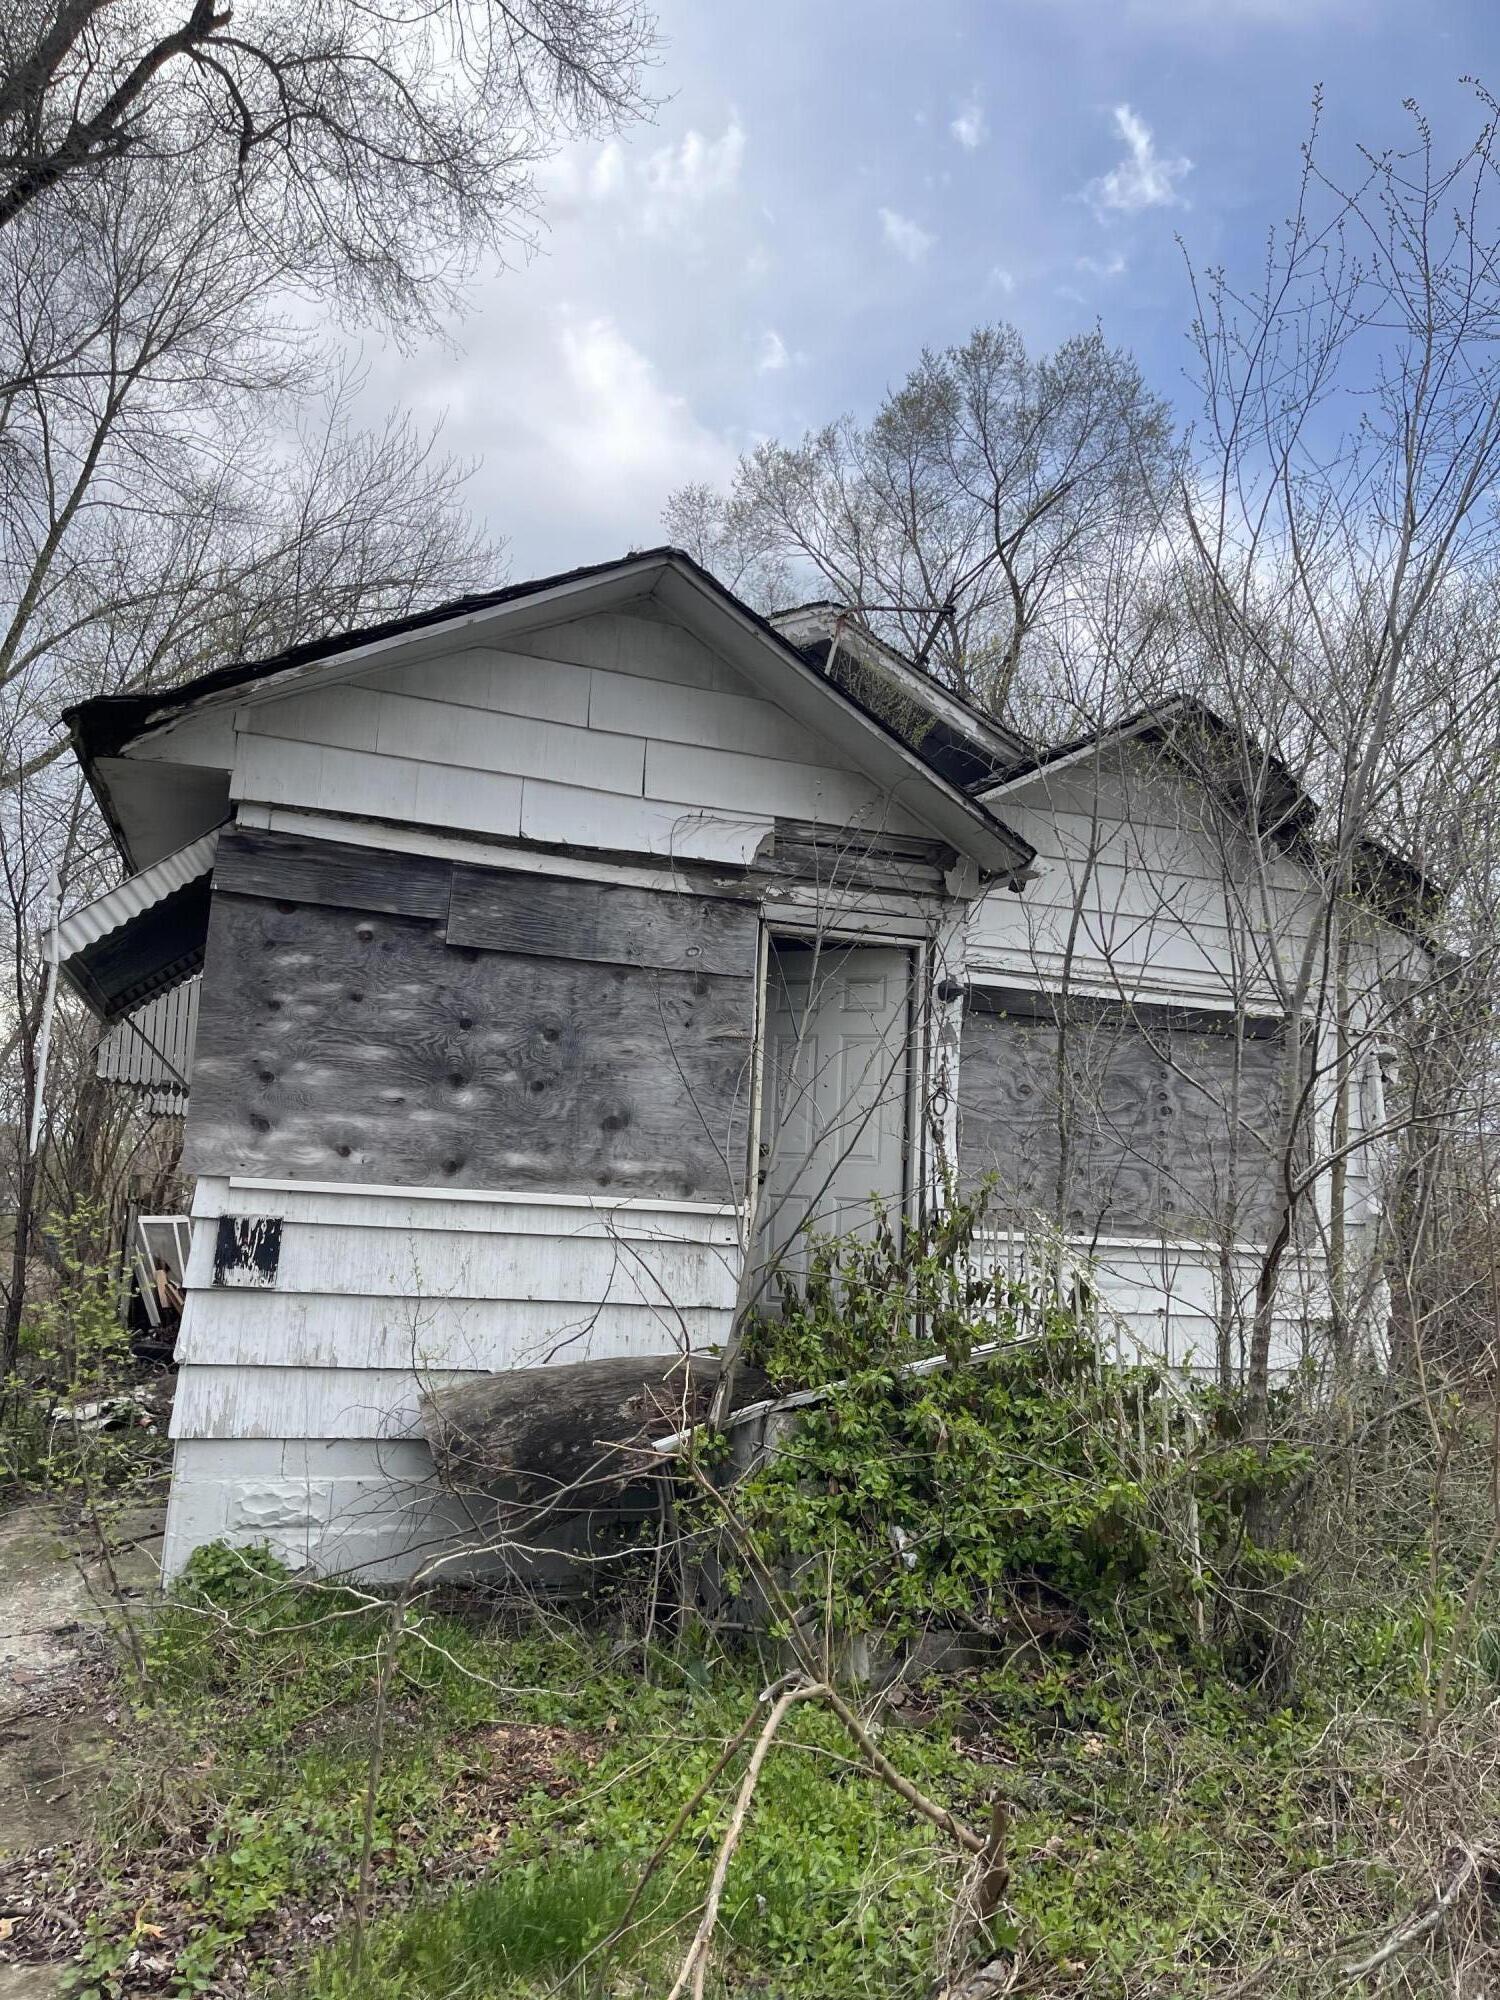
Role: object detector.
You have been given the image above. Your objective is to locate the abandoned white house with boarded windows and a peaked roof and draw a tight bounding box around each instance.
[58,550,1424,1572]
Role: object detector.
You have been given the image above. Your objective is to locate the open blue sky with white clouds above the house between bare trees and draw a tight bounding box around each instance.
[364,0,1500,576]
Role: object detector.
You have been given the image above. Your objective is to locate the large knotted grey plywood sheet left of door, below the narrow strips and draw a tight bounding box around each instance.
[184,894,754,1200]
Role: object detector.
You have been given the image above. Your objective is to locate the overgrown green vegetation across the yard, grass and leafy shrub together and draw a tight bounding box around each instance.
[2,1204,1500,2000]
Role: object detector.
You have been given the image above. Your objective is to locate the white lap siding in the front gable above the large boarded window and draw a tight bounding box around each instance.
[232,612,924,862]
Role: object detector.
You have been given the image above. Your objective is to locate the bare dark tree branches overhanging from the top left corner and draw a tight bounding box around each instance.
[0,0,654,324]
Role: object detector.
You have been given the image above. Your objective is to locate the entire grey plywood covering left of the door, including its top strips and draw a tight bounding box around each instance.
[186,834,756,1202]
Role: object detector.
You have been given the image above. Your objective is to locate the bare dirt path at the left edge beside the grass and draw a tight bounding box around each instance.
[0,1502,164,2000]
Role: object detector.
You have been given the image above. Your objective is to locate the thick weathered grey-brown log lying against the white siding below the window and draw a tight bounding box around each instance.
[420,1354,768,1512]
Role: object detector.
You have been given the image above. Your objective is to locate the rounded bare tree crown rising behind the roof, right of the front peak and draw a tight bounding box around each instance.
[666,326,1174,716]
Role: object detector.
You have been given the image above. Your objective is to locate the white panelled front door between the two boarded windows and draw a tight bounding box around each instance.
[760,940,912,1270]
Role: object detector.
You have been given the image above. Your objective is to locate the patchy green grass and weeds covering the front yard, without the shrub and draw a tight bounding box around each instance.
[55,1556,1500,2000]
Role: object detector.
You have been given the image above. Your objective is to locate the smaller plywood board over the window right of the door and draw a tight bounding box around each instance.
[958,988,1284,1238]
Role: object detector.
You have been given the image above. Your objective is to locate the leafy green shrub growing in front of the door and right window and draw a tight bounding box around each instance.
[722,1198,1304,1636]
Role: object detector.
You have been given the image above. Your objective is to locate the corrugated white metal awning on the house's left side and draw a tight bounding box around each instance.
[56,830,218,1020]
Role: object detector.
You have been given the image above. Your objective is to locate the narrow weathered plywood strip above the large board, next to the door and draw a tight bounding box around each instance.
[448,862,758,980]
